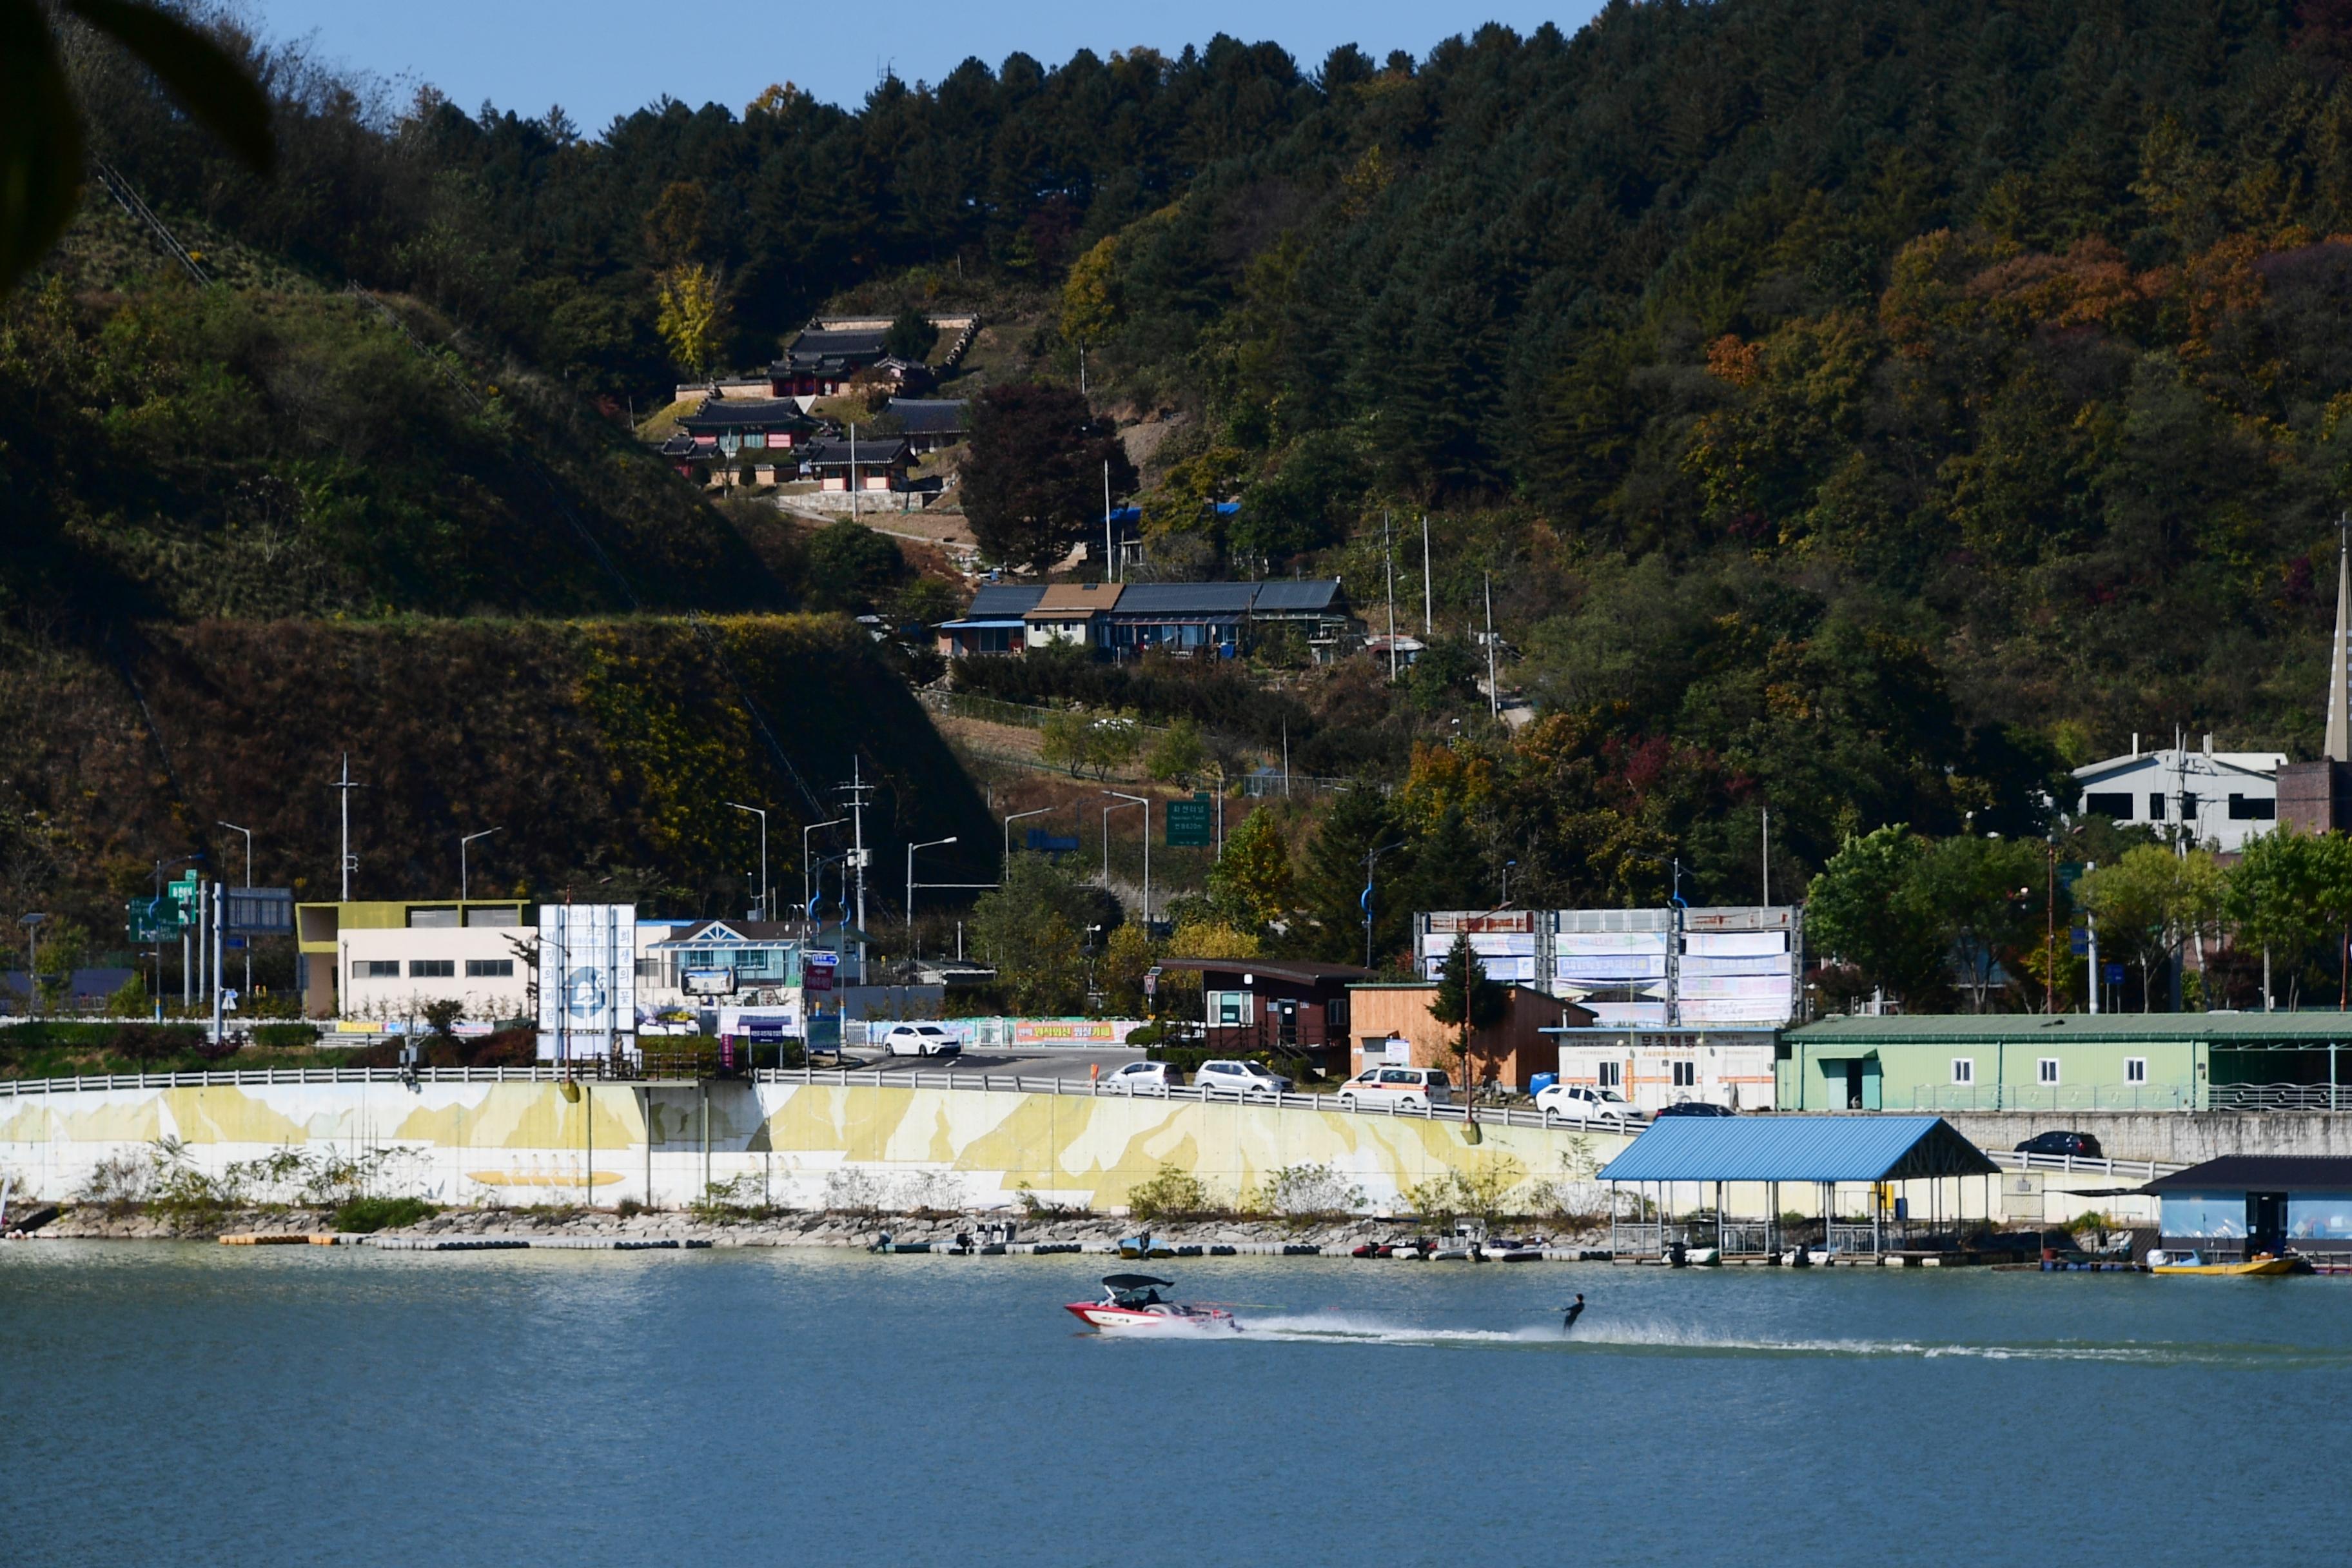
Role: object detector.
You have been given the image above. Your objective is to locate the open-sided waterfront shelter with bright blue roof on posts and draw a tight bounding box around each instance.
[1600,1117,1999,1255]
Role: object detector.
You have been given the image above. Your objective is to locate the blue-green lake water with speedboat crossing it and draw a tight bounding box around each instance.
[0,1241,2352,1568]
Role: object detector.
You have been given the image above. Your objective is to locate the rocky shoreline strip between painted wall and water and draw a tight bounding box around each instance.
[10,1204,1609,1253]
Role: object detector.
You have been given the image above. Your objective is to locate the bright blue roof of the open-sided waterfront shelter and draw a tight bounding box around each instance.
[1602,1117,1999,1182]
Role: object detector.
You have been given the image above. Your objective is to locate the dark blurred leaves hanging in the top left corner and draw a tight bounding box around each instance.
[0,0,277,294]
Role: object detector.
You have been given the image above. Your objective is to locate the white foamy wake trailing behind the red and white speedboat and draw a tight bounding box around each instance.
[1237,1312,2352,1368]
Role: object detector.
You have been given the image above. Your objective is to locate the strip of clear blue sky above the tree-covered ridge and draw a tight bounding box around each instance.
[244,0,1600,134]
